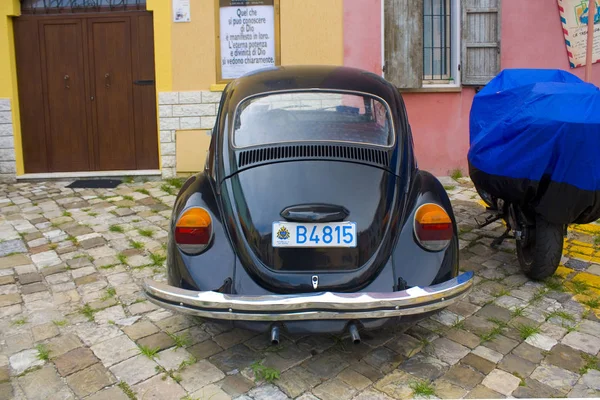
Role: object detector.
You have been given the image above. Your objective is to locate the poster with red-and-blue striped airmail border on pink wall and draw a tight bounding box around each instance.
[558,0,600,68]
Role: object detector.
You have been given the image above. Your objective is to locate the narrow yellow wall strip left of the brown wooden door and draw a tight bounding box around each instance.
[0,0,24,175]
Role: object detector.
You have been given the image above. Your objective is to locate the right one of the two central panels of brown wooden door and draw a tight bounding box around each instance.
[88,17,136,171]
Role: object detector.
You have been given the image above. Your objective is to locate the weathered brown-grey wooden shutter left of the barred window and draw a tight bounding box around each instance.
[384,0,423,89]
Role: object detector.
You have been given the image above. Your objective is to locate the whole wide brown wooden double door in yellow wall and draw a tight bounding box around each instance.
[14,12,158,173]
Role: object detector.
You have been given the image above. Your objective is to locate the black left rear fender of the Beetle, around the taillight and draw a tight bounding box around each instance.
[167,173,236,293]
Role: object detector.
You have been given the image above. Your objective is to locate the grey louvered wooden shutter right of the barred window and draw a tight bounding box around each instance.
[461,0,500,85]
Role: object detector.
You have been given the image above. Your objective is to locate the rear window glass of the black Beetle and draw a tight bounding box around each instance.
[233,91,393,147]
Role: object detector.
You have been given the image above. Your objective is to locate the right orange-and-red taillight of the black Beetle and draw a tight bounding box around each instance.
[414,203,454,251]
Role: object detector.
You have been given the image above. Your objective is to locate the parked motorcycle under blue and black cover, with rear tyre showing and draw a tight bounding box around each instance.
[468,69,600,279]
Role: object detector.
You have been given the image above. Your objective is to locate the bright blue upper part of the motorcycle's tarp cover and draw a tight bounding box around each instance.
[468,69,600,223]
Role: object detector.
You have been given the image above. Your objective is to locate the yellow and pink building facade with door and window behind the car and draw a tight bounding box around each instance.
[0,0,600,180]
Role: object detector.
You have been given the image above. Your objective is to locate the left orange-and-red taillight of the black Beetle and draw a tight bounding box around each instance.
[175,207,212,254]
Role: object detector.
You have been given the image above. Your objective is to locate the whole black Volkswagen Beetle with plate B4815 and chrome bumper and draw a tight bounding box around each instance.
[144,66,473,342]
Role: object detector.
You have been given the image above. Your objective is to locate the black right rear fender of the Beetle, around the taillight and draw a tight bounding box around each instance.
[392,171,458,290]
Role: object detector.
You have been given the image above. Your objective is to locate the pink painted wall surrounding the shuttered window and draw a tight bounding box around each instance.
[344,0,600,175]
